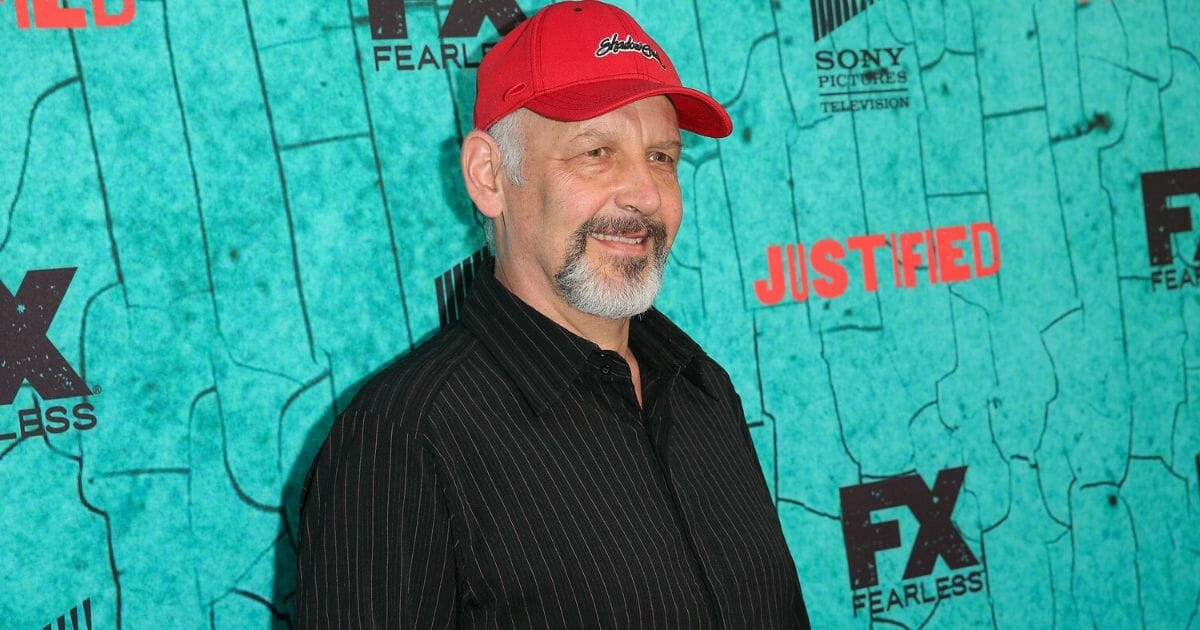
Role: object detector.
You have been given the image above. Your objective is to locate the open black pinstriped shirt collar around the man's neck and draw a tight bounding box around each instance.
[462,271,716,413]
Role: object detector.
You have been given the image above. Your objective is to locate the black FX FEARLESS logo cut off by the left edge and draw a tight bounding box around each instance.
[0,266,100,443]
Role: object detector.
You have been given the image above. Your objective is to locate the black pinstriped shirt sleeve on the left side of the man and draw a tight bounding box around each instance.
[295,412,457,629]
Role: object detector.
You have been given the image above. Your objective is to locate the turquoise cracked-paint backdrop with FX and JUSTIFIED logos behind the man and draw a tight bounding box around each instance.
[0,0,1200,629]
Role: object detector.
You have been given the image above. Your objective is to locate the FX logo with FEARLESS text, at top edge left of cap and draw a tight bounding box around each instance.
[367,0,526,72]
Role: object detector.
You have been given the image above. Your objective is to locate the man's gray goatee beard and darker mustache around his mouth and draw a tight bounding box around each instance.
[554,217,667,319]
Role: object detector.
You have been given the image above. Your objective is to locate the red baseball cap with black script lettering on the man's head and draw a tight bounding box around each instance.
[475,0,733,138]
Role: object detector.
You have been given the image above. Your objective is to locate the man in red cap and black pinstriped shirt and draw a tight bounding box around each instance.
[296,0,808,629]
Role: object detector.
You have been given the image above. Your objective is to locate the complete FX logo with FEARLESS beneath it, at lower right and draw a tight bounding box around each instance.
[840,466,986,618]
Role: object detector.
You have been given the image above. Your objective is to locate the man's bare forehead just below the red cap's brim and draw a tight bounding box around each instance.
[529,96,679,144]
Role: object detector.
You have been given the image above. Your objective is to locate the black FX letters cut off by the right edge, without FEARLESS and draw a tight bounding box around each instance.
[1141,168,1200,266]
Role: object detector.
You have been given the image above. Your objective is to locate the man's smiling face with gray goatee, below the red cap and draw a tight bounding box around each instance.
[498,96,683,318]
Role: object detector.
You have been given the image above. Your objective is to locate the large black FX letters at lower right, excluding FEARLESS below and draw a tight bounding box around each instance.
[840,466,979,590]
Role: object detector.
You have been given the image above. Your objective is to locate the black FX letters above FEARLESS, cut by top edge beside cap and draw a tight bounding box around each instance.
[367,0,524,40]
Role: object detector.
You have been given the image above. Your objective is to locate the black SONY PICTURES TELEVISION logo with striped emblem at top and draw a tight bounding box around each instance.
[810,0,908,114]
